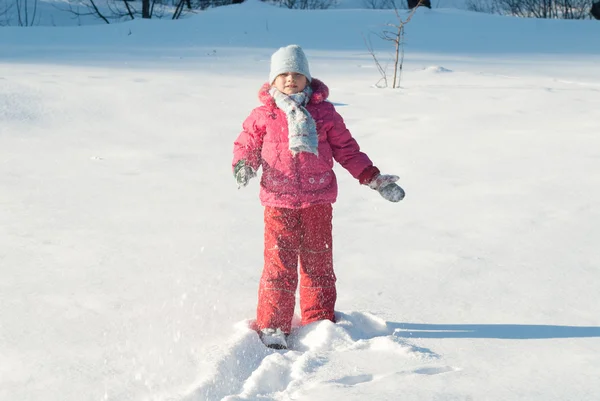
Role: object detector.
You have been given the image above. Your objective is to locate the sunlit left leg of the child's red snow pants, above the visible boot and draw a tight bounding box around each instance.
[256,207,301,333]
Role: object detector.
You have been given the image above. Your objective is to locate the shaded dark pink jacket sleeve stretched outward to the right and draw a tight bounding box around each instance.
[328,105,374,181]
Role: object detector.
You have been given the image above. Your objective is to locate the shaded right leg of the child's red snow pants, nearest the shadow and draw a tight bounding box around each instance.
[300,204,336,324]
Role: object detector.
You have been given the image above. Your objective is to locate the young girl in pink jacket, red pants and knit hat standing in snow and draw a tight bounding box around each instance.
[233,45,404,349]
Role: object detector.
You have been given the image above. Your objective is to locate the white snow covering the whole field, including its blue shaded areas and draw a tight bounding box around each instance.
[0,1,600,401]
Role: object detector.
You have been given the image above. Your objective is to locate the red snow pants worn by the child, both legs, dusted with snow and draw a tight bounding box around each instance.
[256,203,336,333]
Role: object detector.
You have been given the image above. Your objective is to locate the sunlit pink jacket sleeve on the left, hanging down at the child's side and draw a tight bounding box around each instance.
[232,107,266,171]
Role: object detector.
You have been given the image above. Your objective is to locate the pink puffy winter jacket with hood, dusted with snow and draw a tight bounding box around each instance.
[232,78,379,209]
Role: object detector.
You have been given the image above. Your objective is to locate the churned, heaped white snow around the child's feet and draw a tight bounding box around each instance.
[183,312,457,401]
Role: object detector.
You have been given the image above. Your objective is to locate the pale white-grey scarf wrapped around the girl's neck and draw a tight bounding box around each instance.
[269,86,319,156]
